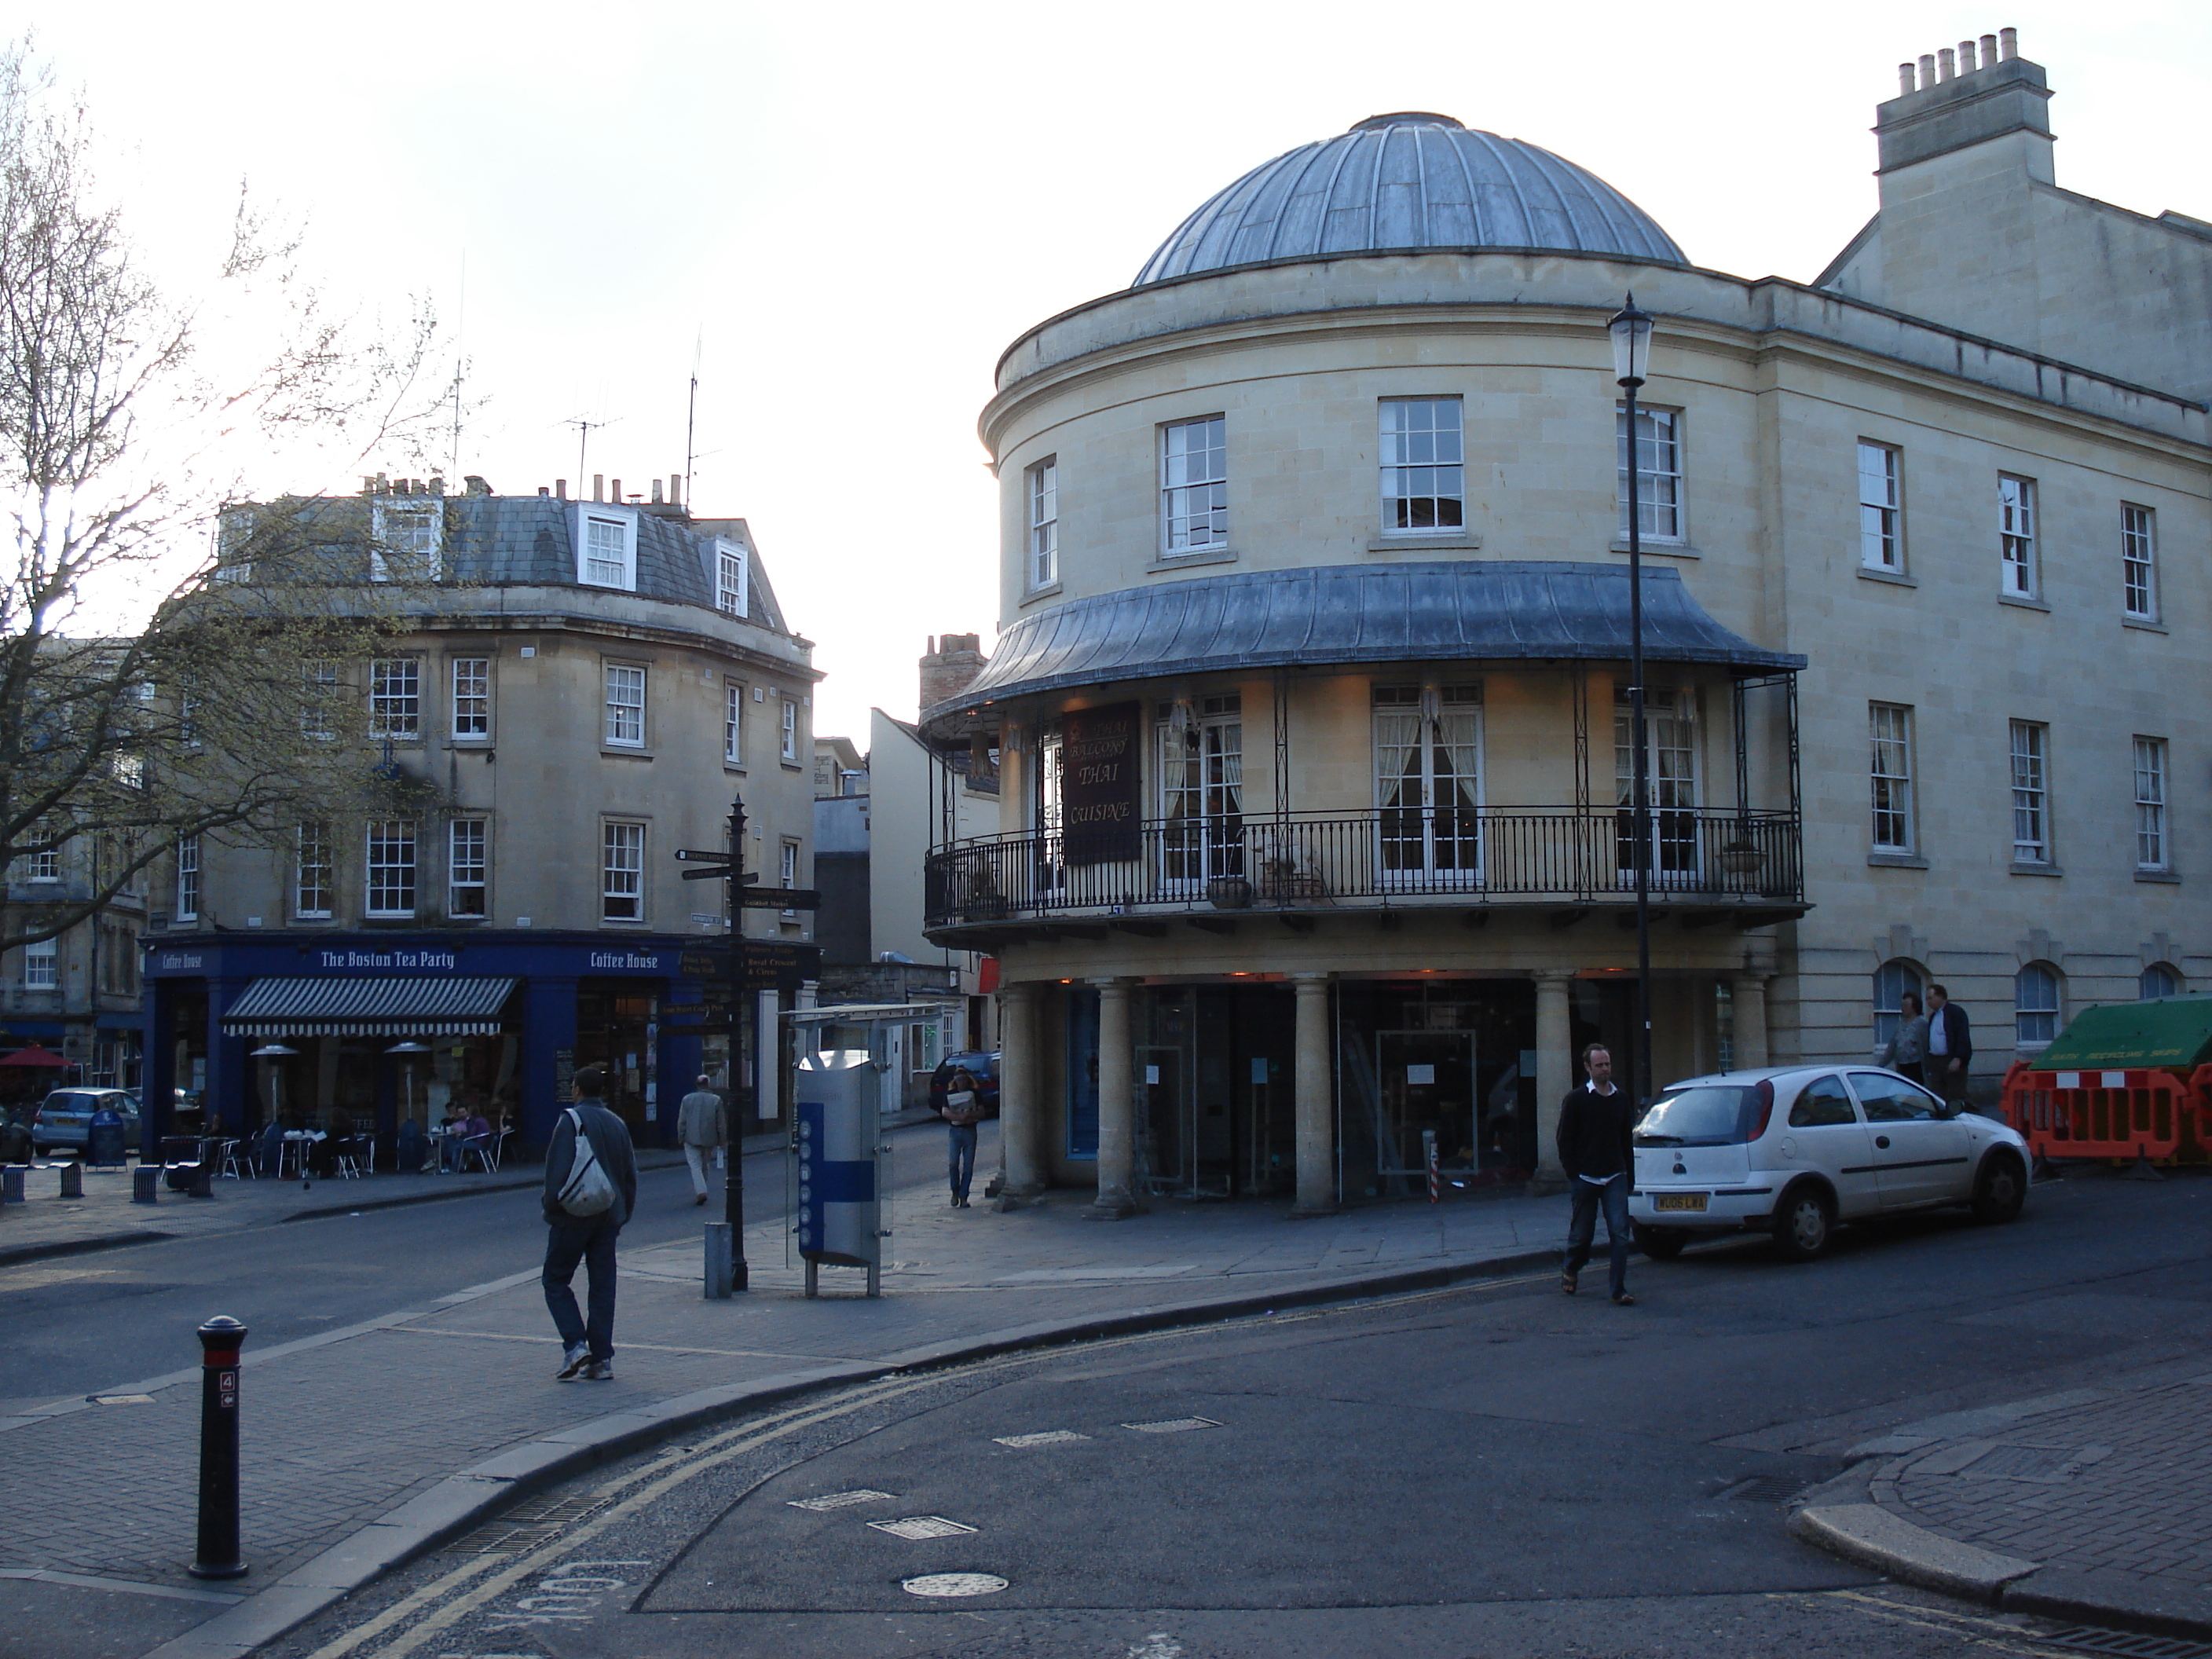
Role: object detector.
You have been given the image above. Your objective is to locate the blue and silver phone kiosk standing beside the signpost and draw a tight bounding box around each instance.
[792,1049,887,1296]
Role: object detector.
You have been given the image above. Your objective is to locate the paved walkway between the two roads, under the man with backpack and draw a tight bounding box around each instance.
[0,1146,1566,1654]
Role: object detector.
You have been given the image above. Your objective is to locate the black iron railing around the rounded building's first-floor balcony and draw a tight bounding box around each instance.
[925,808,1805,927]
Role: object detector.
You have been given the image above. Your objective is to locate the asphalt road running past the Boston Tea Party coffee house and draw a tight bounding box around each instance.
[0,1124,969,1434]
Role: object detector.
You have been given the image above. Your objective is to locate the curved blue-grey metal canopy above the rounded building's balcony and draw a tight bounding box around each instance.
[922,559,1805,734]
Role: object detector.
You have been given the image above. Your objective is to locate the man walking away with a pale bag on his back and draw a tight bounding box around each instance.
[544,1066,637,1382]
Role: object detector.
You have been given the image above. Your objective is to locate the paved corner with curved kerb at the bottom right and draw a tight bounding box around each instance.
[1794,1356,2212,1637]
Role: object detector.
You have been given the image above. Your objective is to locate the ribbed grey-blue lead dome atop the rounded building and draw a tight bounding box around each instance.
[1130,111,1688,287]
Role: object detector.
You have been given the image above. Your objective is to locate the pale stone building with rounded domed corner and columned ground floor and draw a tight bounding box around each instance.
[922,33,2212,1212]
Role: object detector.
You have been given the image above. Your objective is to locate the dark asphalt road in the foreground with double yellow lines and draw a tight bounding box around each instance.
[276,1179,2212,1659]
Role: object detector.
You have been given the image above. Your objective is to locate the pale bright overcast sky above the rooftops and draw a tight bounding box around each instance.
[35,0,2212,743]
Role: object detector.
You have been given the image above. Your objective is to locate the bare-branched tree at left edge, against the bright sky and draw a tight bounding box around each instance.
[0,44,438,949]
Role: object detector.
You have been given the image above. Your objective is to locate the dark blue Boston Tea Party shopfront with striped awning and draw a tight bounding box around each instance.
[144,933,730,1146]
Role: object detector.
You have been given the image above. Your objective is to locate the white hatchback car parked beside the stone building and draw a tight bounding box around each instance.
[1628,1066,2028,1261]
